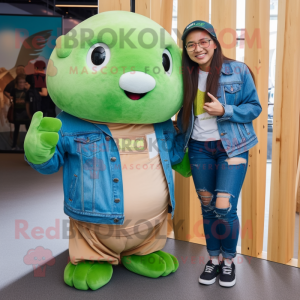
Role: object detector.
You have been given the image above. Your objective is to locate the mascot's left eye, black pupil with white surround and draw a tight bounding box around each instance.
[86,43,111,72]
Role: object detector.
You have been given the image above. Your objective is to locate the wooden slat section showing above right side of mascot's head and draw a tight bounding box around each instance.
[135,0,173,34]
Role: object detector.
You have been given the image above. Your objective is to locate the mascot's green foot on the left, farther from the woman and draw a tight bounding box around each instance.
[64,261,113,290]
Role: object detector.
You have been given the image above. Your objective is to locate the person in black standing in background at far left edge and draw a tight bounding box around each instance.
[10,74,30,150]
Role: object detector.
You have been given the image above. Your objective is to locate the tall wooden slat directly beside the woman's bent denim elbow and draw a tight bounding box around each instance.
[241,0,270,257]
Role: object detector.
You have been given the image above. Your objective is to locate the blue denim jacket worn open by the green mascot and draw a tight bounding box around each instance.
[25,112,184,225]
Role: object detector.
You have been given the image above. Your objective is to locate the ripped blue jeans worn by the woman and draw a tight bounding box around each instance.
[188,139,249,258]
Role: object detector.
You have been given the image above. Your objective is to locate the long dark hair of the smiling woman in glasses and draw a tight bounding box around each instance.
[182,29,255,131]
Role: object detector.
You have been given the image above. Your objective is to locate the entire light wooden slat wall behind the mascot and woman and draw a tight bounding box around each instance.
[99,0,300,267]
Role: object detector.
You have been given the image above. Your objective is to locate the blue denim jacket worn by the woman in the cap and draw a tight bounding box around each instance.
[177,61,262,157]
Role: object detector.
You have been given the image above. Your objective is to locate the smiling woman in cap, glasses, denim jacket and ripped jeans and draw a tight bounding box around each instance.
[177,21,262,287]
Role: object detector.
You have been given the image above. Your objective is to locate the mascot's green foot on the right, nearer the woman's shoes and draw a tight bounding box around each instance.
[122,251,179,278]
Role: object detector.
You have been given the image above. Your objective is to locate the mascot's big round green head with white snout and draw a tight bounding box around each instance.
[47,11,183,124]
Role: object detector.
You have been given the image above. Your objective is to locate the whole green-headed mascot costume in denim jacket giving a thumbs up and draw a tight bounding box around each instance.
[24,11,185,290]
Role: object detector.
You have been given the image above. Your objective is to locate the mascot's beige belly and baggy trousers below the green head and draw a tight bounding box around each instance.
[69,122,170,264]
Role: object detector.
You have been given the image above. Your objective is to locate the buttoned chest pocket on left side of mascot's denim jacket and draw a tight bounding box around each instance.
[74,133,102,157]
